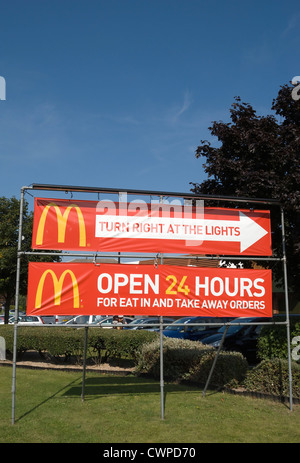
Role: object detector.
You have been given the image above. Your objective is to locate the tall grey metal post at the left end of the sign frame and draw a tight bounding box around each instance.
[11,188,24,424]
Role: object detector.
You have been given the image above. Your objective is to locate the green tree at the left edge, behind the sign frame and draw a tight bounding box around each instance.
[0,197,59,323]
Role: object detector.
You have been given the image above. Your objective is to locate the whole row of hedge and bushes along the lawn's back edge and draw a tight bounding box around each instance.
[0,323,300,399]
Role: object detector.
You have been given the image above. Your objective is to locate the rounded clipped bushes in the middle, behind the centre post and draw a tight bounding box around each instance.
[135,338,248,387]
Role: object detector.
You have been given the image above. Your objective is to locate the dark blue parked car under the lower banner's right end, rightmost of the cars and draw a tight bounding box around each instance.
[201,317,274,364]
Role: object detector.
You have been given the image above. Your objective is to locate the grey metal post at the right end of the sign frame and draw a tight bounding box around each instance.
[281,206,293,411]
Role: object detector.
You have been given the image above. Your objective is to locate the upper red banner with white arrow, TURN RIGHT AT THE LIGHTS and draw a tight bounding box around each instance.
[32,198,272,256]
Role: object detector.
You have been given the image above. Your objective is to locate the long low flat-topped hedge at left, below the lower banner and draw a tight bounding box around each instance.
[0,325,159,363]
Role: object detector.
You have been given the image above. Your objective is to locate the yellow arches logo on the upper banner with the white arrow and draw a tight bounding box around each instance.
[36,203,86,247]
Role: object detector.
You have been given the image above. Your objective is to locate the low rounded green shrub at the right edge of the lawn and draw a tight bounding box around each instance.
[243,359,300,398]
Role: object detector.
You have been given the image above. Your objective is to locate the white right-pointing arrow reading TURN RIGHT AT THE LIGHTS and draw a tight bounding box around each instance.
[95,211,268,252]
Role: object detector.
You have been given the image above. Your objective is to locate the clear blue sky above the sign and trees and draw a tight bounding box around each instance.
[0,0,300,204]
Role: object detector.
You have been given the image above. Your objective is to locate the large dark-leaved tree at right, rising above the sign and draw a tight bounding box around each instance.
[192,85,300,296]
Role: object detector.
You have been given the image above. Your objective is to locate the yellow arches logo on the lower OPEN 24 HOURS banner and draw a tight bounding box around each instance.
[35,269,79,309]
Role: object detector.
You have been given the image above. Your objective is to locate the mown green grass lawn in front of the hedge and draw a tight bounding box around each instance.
[0,366,300,444]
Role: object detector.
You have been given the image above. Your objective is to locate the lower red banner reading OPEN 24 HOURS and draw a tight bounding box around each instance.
[27,262,272,317]
